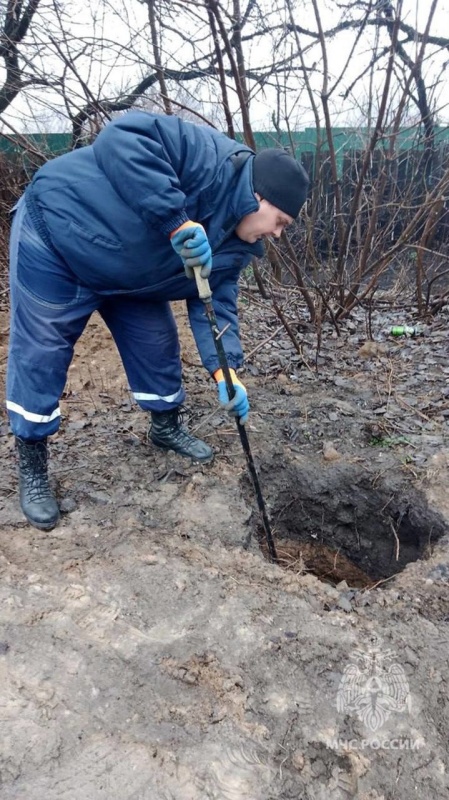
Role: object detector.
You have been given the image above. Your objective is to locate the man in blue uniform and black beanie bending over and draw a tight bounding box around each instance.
[7,111,308,530]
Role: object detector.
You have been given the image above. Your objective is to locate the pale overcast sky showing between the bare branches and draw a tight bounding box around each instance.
[0,0,449,130]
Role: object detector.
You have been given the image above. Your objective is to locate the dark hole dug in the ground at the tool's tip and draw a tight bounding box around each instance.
[257,465,447,588]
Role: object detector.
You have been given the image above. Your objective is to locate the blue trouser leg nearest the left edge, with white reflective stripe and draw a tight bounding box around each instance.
[6,198,98,440]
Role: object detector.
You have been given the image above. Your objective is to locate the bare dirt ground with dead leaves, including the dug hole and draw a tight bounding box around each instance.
[0,292,449,800]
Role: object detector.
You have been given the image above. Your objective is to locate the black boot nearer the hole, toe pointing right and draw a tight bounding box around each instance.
[148,407,214,462]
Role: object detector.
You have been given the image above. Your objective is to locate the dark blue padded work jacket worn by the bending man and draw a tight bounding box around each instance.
[26,111,263,372]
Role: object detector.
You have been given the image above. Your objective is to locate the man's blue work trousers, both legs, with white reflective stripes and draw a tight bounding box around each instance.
[6,198,185,440]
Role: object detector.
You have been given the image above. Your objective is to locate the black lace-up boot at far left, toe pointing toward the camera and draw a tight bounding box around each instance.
[16,436,59,531]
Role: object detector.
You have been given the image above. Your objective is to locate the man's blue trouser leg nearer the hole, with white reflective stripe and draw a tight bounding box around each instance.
[100,297,185,411]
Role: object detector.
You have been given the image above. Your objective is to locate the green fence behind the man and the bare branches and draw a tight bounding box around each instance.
[0,127,449,247]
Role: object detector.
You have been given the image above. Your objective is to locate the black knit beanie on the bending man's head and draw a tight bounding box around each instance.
[253,148,309,219]
